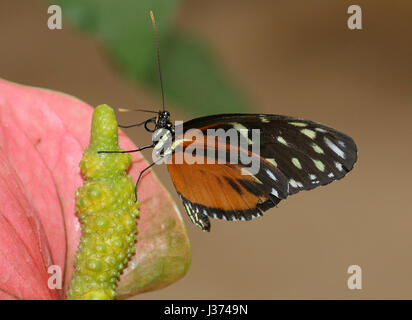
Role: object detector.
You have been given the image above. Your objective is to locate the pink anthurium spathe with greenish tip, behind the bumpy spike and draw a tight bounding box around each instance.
[0,80,191,299]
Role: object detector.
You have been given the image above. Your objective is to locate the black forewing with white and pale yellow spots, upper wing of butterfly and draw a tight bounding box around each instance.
[183,114,357,198]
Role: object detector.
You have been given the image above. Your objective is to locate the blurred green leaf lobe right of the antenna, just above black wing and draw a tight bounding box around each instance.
[147,33,247,114]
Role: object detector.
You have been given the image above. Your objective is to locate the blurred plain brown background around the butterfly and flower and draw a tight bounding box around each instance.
[0,0,412,299]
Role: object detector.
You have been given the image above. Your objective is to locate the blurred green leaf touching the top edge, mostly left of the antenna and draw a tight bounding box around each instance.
[55,0,179,81]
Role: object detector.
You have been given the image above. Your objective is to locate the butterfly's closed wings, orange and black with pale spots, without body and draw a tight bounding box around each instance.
[169,114,357,231]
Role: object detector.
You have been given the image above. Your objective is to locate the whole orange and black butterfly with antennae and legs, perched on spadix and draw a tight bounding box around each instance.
[97,13,357,231]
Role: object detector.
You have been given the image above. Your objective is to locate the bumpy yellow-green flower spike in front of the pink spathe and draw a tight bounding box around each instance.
[67,105,139,300]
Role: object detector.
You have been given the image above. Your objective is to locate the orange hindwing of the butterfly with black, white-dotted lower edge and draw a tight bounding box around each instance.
[168,143,289,231]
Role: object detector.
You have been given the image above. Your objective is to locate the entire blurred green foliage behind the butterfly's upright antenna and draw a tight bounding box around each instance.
[54,0,248,114]
